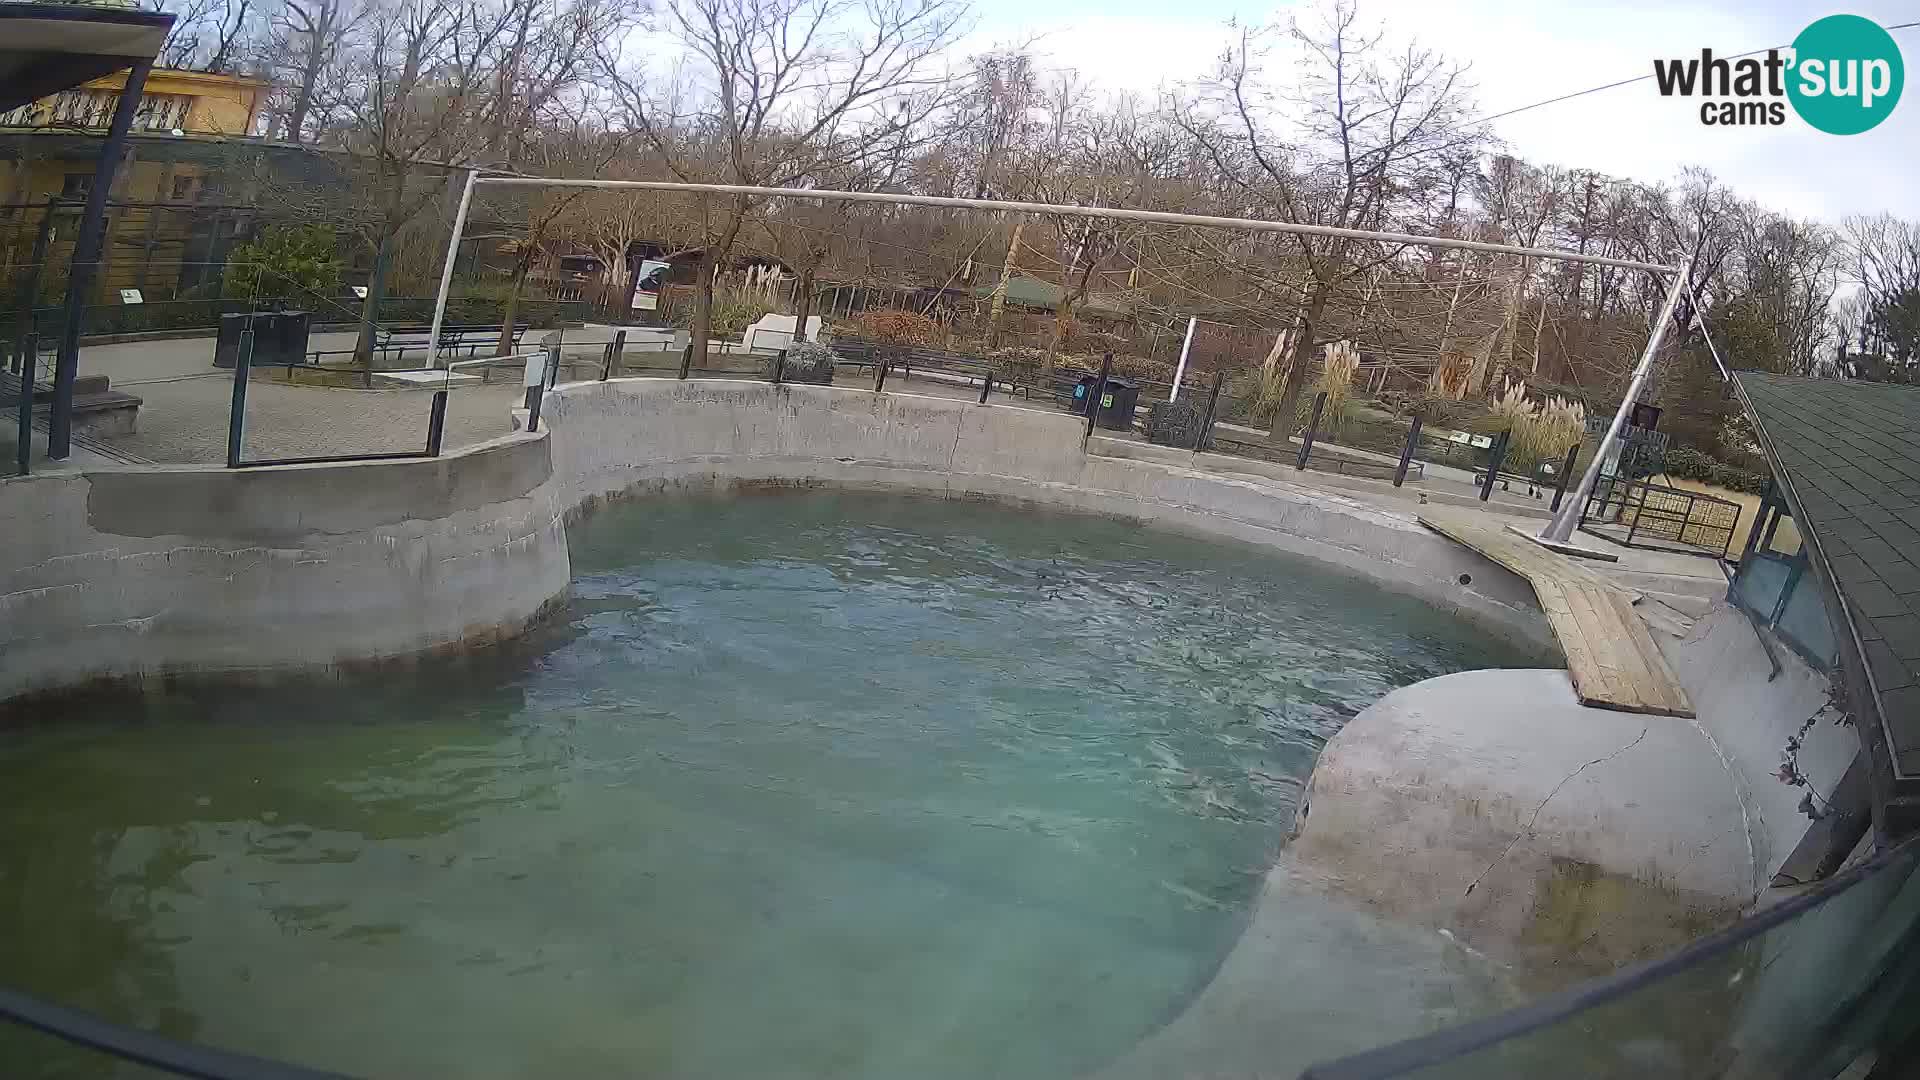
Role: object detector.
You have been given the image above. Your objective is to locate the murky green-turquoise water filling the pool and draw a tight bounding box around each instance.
[0,494,1530,1078]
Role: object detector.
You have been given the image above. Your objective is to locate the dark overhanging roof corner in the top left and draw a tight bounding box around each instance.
[0,4,173,111]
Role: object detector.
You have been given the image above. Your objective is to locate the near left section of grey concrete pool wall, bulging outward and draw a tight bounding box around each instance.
[0,434,570,700]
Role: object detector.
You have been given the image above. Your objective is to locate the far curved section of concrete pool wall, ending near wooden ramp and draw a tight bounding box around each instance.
[541,379,1559,655]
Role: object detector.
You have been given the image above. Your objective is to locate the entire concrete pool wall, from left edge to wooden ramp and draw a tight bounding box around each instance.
[0,379,1553,701]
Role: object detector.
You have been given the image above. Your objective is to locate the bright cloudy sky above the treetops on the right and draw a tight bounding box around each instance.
[972,0,1920,221]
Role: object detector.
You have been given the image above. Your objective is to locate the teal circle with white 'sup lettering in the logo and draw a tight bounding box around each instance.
[1788,15,1907,135]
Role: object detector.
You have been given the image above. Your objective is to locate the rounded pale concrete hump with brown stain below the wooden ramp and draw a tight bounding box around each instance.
[1290,671,1755,988]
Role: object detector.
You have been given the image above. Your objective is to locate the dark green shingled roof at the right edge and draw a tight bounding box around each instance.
[1734,371,1920,780]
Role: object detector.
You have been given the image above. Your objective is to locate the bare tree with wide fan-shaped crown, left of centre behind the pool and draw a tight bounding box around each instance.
[601,0,966,361]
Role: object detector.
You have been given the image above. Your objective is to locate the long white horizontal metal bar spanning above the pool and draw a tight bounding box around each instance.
[474,177,1686,275]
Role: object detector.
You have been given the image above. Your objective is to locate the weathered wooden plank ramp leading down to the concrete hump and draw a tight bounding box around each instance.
[1419,509,1693,717]
